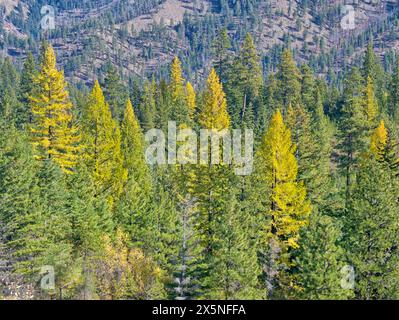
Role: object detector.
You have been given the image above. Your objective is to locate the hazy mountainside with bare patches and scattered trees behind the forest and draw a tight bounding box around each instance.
[0,0,399,82]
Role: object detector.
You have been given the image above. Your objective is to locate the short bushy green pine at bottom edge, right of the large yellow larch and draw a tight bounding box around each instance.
[293,211,353,300]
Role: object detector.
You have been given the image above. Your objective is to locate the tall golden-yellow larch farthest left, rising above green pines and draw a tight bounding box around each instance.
[29,45,80,173]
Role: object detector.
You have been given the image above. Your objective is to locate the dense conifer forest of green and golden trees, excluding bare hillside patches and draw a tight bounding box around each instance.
[0,0,399,300]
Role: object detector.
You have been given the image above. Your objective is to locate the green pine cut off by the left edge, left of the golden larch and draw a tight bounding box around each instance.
[0,122,43,275]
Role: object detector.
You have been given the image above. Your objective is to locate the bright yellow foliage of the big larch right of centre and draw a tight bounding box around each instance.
[257,111,311,250]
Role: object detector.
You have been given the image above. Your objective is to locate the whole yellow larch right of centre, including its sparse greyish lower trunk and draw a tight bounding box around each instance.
[256,111,311,296]
